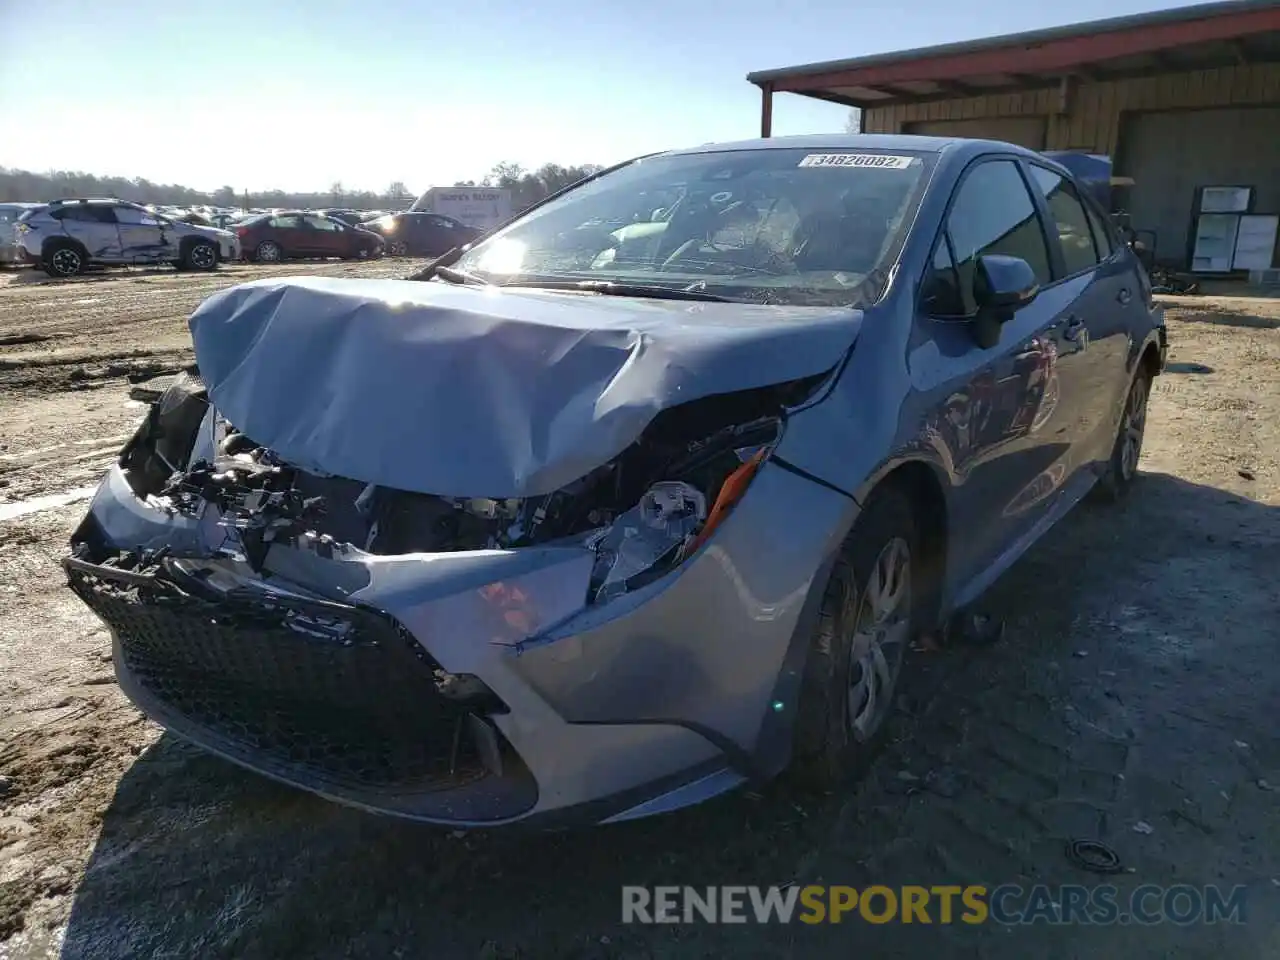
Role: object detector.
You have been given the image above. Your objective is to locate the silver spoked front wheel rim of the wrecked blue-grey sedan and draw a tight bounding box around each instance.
[846,538,911,741]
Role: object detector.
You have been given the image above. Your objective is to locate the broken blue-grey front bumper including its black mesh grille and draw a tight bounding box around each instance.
[67,463,854,826]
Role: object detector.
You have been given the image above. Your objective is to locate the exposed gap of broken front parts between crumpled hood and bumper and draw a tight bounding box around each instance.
[120,371,822,602]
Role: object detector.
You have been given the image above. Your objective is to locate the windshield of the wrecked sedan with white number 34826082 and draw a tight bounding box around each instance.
[456,148,934,306]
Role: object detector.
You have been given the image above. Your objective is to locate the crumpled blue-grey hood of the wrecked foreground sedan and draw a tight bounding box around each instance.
[191,278,861,498]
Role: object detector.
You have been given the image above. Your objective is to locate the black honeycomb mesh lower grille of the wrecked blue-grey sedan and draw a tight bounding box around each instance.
[68,561,485,794]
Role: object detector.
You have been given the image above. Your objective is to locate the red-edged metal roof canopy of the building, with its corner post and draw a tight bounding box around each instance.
[746,0,1280,137]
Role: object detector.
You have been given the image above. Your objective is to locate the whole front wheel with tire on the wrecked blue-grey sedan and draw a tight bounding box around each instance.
[792,486,922,787]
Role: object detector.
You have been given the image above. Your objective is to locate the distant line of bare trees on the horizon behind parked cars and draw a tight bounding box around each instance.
[0,163,600,210]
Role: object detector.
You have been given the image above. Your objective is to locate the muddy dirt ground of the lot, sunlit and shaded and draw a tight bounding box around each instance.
[0,262,1280,960]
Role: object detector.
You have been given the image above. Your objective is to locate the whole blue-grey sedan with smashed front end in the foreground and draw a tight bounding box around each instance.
[65,137,1164,826]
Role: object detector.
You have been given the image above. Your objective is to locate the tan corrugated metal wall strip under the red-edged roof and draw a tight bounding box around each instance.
[863,64,1280,155]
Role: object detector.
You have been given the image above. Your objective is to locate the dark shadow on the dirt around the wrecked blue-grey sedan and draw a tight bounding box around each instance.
[63,474,1280,960]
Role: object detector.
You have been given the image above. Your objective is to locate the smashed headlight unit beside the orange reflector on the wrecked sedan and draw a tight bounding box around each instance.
[593,480,707,600]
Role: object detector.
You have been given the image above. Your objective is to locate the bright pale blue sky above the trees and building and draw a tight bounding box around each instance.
[0,0,1203,192]
